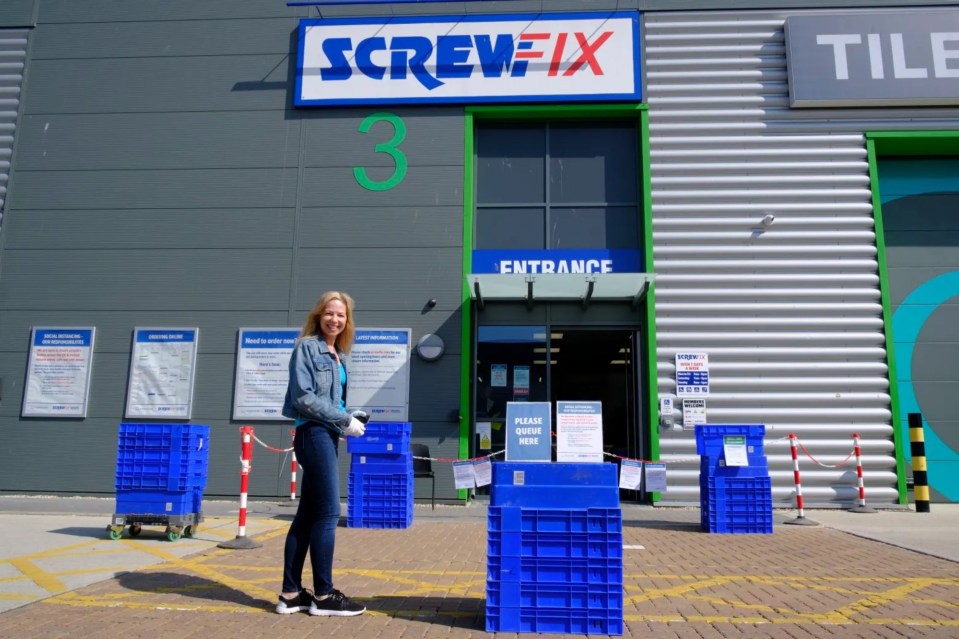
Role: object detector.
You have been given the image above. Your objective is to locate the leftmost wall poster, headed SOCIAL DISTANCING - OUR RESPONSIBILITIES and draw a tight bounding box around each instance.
[20,327,96,417]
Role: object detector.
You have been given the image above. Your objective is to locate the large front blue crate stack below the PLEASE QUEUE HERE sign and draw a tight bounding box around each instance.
[486,462,624,635]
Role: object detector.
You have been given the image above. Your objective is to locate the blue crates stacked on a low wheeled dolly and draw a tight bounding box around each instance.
[115,424,210,517]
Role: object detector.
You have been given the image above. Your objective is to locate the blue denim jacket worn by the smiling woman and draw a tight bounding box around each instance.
[283,336,350,430]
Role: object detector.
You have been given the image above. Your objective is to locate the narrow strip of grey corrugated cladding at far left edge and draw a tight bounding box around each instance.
[0,29,30,228]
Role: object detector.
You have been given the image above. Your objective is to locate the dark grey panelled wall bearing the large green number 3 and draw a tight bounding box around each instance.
[0,0,463,497]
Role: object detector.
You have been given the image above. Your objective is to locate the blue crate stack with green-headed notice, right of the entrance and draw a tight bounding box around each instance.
[696,424,773,534]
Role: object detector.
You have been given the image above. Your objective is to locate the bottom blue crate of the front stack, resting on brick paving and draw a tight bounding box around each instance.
[486,606,623,635]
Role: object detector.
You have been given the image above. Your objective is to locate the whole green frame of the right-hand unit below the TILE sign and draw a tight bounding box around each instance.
[866,131,959,505]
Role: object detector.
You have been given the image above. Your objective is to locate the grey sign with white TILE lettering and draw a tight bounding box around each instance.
[785,9,959,107]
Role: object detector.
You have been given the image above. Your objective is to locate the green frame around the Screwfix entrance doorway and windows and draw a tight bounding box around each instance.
[458,104,659,500]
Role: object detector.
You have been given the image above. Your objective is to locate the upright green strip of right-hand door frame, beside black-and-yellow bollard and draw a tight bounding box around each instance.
[866,135,909,504]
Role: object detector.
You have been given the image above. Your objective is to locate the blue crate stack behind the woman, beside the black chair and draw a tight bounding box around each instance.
[346,422,413,528]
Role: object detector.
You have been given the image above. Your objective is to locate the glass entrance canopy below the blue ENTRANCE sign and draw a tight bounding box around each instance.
[466,273,655,308]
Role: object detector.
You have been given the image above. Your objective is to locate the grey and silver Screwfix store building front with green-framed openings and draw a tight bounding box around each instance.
[0,0,959,507]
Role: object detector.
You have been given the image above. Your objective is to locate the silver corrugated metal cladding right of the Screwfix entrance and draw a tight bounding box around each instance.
[644,8,959,505]
